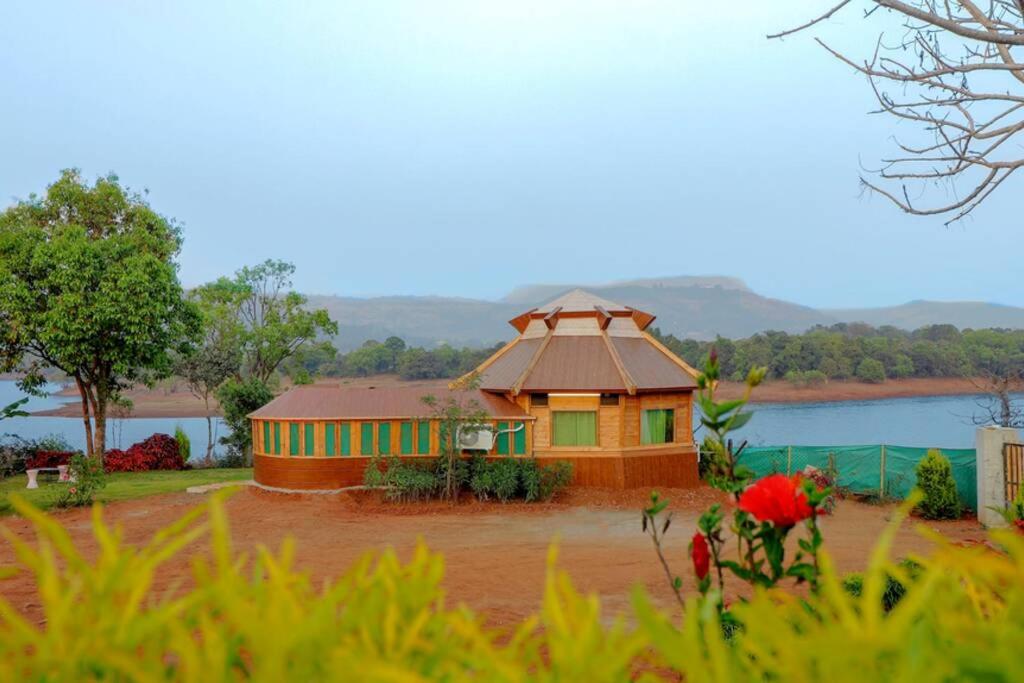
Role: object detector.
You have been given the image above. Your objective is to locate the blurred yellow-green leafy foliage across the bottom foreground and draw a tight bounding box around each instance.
[0,497,1024,683]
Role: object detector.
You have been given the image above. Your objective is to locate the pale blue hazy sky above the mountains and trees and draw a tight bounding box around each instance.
[0,0,1024,306]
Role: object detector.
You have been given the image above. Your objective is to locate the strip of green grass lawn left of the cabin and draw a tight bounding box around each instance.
[0,467,253,515]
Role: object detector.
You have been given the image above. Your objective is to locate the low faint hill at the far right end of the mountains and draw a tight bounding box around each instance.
[824,301,1024,330]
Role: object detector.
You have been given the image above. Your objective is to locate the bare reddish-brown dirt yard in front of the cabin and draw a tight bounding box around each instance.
[0,487,984,626]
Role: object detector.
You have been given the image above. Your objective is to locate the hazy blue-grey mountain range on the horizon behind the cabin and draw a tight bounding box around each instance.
[308,275,1024,350]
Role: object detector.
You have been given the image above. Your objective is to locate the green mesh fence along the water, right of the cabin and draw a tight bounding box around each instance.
[739,444,978,509]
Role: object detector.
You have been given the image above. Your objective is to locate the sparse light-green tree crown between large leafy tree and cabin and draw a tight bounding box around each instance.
[199,260,338,384]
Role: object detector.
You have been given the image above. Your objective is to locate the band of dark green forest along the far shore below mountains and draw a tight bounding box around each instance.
[289,323,1024,384]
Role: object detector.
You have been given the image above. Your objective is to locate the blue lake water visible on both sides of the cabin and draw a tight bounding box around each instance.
[0,381,1011,454]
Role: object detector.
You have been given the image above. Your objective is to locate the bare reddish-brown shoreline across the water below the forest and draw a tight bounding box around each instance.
[16,375,984,420]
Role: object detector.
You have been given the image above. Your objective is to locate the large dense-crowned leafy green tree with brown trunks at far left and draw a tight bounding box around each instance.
[0,170,199,458]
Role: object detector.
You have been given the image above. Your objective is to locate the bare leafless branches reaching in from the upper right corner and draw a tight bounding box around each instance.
[769,0,1024,225]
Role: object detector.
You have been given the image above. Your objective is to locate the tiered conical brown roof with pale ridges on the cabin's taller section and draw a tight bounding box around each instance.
[475,289,696,395]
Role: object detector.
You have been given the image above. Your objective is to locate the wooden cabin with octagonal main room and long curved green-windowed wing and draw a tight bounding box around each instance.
[249,290,697,489]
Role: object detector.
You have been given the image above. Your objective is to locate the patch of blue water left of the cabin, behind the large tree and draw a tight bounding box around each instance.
[0,380,226,456]
